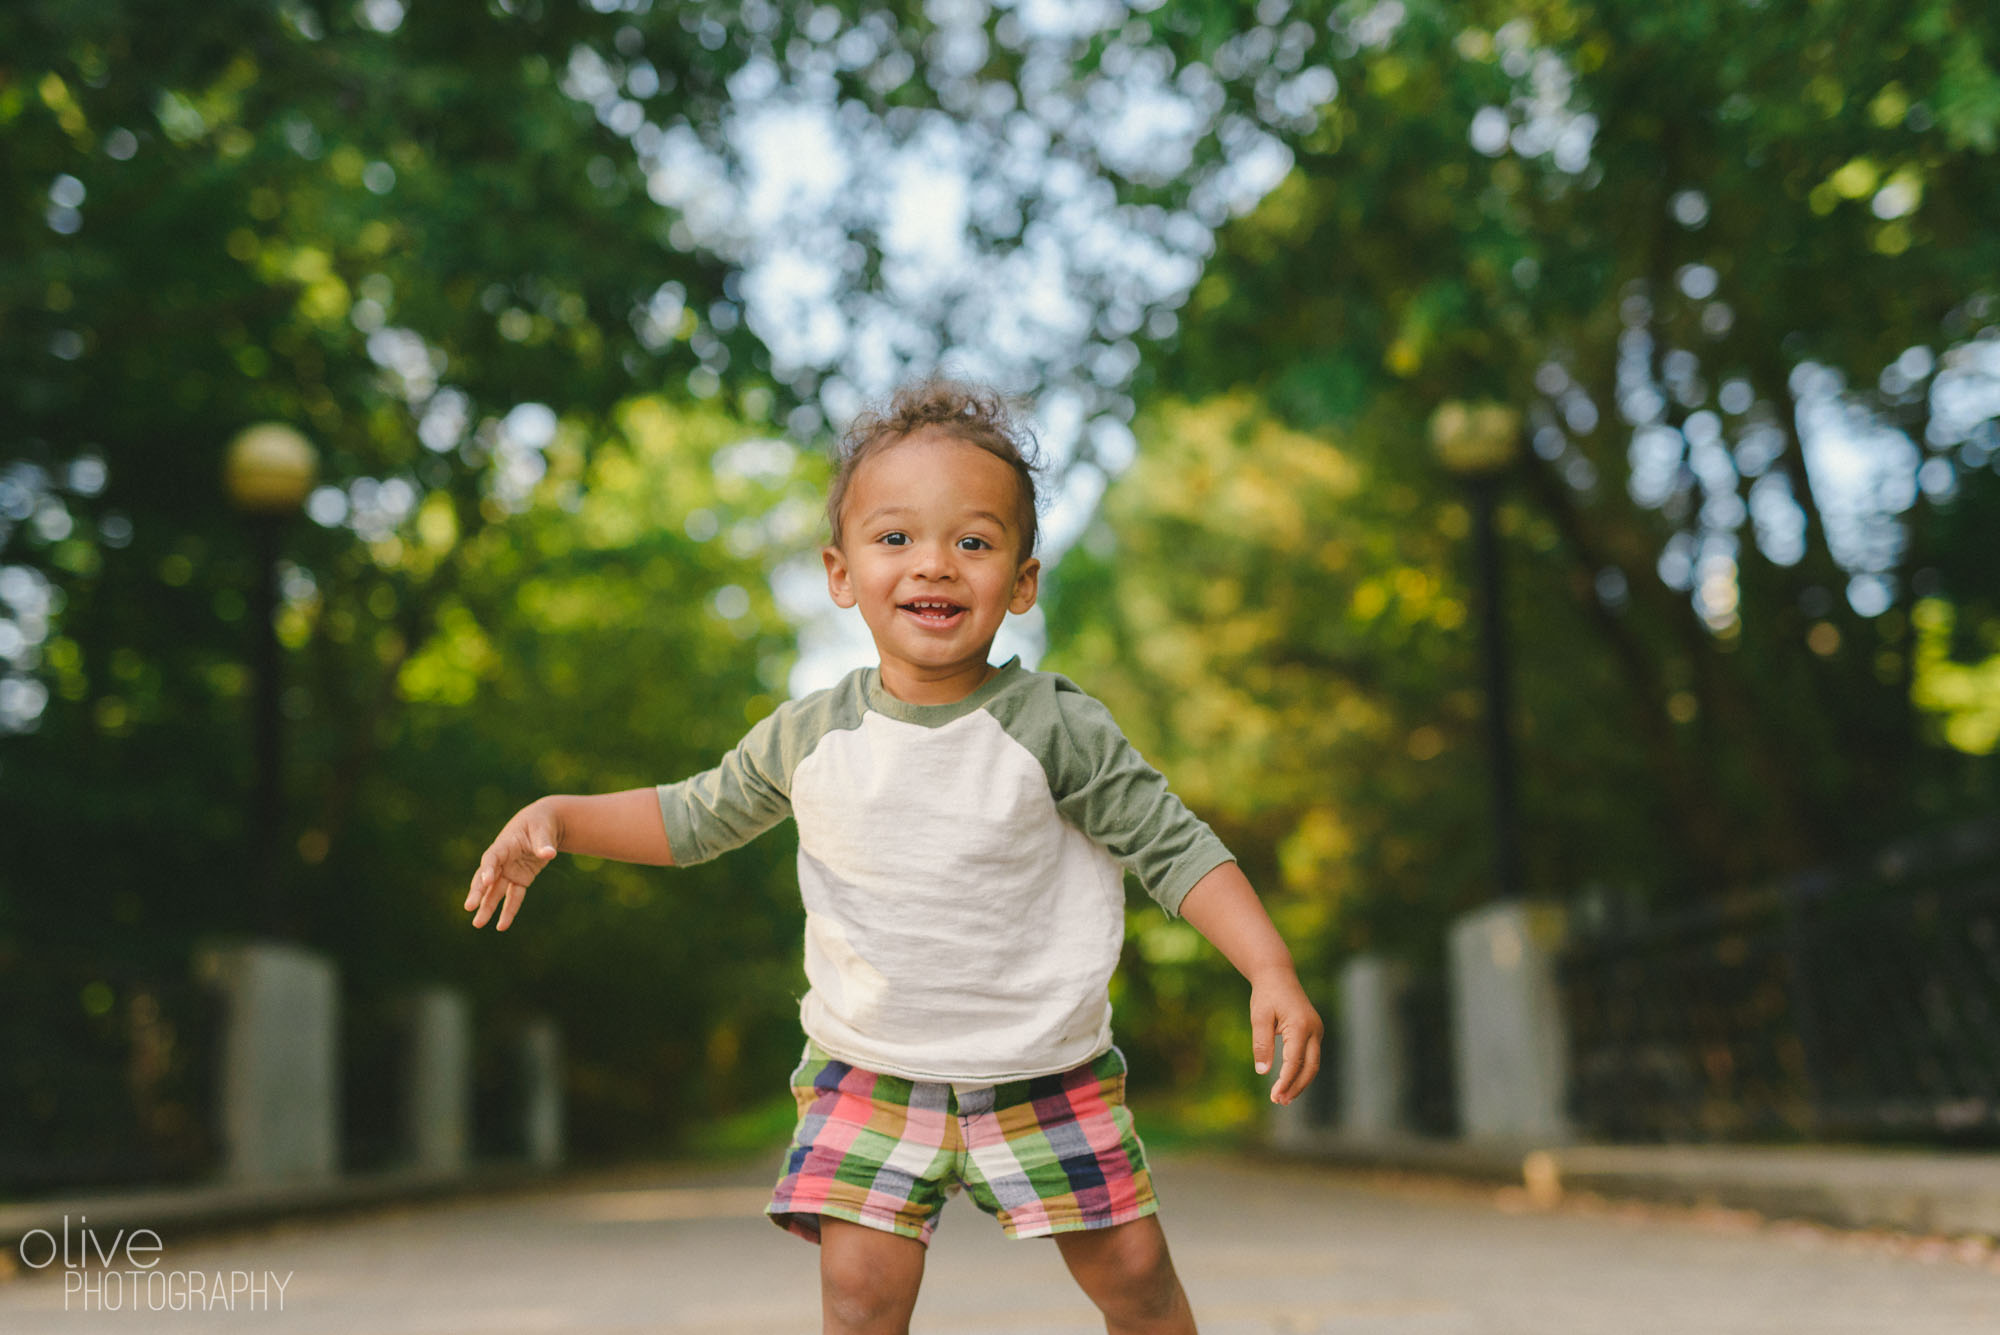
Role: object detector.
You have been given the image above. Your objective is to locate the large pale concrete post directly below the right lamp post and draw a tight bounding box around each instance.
[1450,899,1572,1143]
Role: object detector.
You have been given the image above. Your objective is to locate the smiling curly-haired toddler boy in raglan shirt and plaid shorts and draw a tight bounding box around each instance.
[466,382,1320,1333]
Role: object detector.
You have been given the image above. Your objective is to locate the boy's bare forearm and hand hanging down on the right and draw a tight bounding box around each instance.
[1180,861,1326,1103]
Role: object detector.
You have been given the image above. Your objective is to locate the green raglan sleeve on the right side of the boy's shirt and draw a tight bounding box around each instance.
[1054,681,1234,917]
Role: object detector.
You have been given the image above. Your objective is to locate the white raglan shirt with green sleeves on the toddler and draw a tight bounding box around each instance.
[658,660,1232,1083]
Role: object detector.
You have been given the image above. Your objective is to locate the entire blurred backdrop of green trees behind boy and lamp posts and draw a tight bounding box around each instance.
[0,0,2000,1167]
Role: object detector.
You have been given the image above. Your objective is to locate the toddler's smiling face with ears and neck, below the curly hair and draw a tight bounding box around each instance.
[822,432,1042,703]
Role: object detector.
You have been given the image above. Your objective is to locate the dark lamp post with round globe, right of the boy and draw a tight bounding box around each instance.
[1430,400,1522,899]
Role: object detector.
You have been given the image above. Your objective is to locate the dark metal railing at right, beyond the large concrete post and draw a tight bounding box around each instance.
[1562,821,2000,1141]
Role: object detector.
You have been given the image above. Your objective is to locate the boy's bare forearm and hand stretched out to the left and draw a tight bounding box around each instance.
[466,787,674,931]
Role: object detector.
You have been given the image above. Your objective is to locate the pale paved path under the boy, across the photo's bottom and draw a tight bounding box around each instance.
[0,1159,2000,1335]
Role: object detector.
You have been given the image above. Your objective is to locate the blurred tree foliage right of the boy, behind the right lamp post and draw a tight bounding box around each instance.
[1052,2,2000,959]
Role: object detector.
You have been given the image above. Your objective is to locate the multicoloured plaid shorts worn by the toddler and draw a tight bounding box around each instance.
[764,1041,1158,1245]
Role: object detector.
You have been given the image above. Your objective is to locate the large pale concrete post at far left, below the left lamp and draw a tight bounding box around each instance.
[196,941,340,1185]
